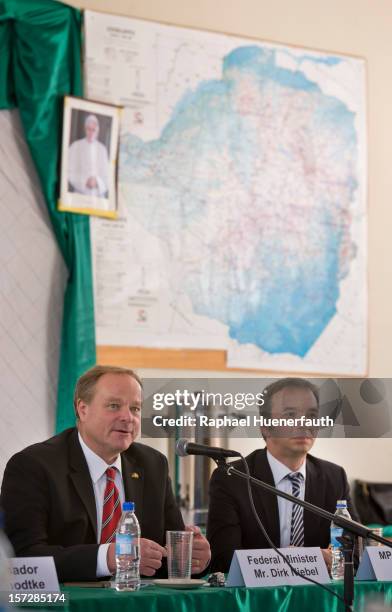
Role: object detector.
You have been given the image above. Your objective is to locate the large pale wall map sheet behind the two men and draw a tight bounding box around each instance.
[85,11,367,374]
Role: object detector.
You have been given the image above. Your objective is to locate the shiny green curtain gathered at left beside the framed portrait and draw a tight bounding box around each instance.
[0,0,96,431]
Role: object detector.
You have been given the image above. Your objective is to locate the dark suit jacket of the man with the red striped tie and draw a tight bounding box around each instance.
[1,429,184,581]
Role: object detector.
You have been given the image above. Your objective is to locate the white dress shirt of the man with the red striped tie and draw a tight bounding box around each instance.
[78,432,125,578]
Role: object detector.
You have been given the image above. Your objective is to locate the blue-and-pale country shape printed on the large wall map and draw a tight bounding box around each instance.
[119,46,358,357]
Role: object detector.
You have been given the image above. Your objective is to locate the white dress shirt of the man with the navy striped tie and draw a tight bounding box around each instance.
[267,450,306,548]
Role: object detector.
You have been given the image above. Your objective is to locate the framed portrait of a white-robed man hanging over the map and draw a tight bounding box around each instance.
[58,96,121,218]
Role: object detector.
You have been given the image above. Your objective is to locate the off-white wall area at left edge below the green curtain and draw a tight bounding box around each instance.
[0,111,66,480]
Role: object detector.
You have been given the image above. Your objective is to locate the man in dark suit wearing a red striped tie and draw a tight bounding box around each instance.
[1,366,210,581]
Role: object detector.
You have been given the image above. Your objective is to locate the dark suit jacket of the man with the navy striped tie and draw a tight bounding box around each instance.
[207,449,358,572]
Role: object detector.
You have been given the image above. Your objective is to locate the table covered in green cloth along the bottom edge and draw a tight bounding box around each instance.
[16,581,392,612]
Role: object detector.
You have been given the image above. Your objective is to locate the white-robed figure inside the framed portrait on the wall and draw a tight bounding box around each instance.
[68,114,109,198]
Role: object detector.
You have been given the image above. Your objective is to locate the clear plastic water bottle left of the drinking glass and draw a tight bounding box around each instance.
[115,502,140,591]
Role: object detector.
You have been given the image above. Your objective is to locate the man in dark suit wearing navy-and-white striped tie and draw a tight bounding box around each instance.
[207,378,358,572]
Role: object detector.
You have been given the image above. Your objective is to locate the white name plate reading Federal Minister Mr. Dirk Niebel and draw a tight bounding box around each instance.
[226,547,330,587]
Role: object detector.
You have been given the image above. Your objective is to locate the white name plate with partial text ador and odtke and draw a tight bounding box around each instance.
[10,557,60,593]
